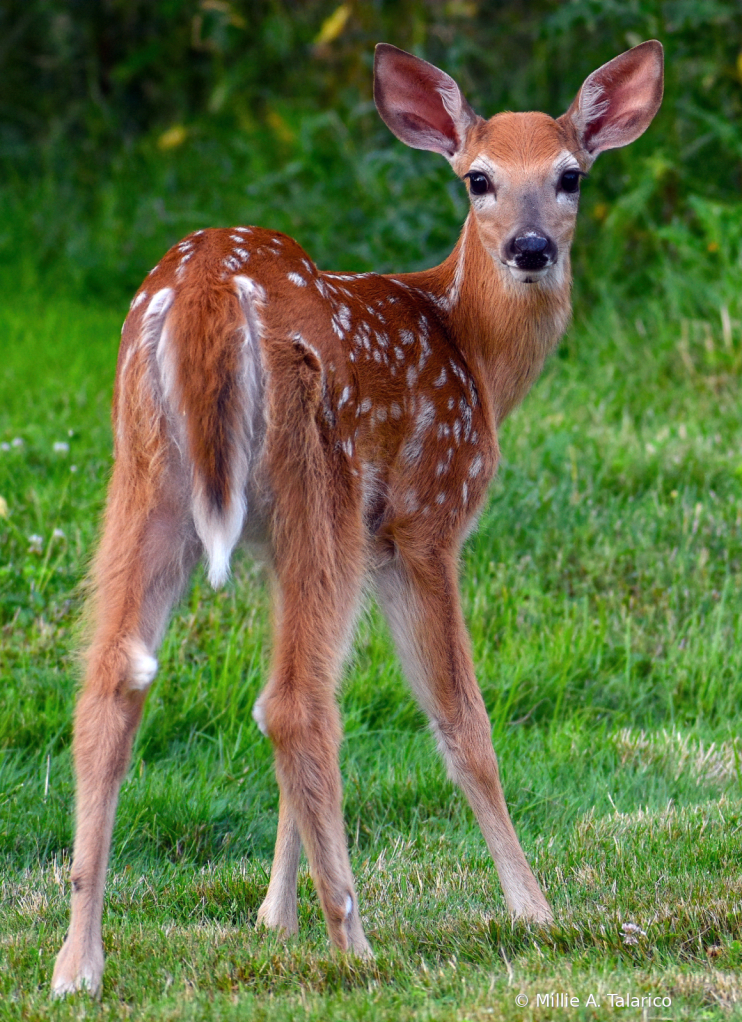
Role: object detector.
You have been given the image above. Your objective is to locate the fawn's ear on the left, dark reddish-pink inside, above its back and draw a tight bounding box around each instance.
[374,43,477,159]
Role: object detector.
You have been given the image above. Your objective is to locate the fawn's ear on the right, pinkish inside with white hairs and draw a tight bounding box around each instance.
[559,39,662,159]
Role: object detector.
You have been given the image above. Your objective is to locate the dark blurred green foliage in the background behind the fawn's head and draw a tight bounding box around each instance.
[0,0,742,299]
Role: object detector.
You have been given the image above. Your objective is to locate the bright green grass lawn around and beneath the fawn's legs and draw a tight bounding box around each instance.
[0,205,742,1020]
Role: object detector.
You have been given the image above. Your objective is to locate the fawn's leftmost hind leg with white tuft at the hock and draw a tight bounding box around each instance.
[52,463,200,995]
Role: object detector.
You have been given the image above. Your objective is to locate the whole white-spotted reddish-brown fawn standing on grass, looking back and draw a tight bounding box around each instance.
[53,42,662,993]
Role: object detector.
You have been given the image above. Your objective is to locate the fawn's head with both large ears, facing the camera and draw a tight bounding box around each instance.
[374,40,662,286]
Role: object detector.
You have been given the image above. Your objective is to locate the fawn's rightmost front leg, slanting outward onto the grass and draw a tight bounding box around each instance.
[376,552,552,923]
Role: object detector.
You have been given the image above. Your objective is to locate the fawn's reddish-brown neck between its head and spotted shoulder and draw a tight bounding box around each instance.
[405,216,571,426]
